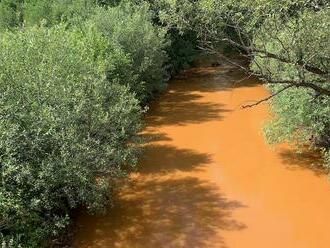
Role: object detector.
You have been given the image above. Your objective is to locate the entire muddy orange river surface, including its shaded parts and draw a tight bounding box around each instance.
[73,62,330,248]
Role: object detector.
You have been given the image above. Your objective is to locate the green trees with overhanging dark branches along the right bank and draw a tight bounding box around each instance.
[155,0,330,166]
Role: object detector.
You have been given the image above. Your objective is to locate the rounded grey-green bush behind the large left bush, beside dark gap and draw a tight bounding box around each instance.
[91,3,167,102]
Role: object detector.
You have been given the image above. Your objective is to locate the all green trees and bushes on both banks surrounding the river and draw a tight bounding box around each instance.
[0,0,330,248]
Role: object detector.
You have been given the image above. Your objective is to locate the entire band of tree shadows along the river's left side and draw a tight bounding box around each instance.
[74,64,246,248]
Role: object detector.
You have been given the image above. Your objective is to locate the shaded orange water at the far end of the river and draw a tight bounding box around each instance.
[146,67,258,127]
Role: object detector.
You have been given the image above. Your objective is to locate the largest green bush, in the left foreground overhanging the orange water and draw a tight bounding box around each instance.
[0,25,141,247]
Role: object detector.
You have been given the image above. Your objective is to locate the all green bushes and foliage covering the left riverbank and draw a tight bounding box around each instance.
[0,0,196,247]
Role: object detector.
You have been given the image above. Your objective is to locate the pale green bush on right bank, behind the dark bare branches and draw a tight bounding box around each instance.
[252,8,330,167]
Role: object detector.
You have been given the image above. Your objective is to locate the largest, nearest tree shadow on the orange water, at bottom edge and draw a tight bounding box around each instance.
[75,177,246,248]
